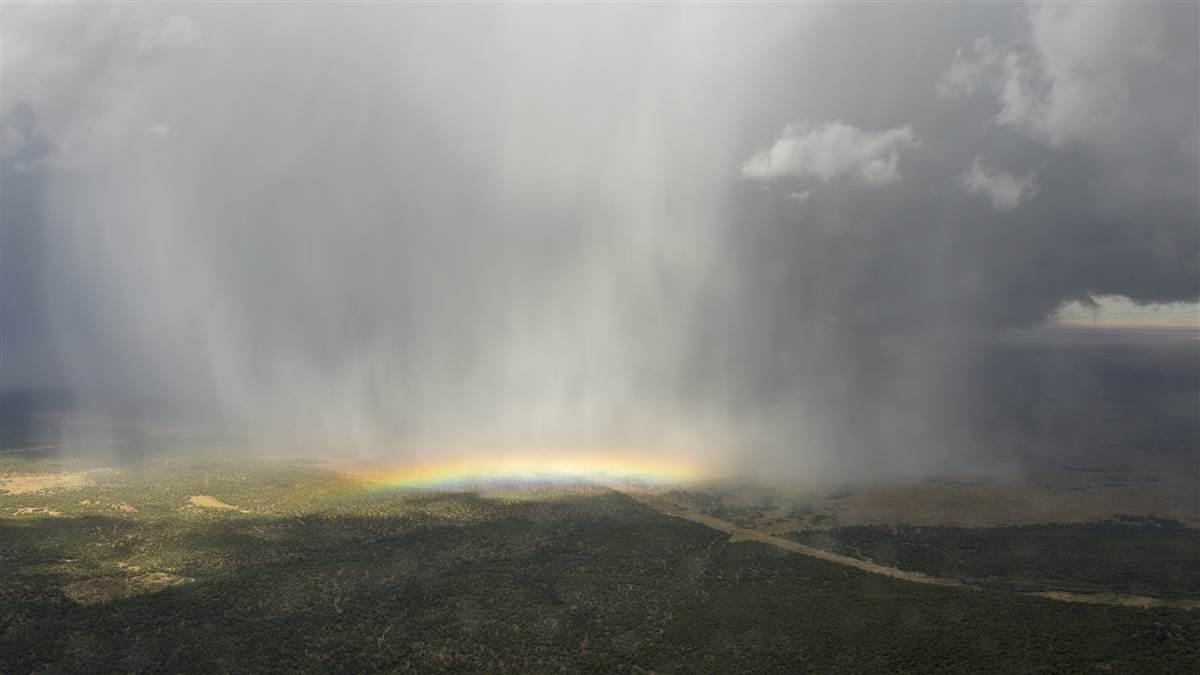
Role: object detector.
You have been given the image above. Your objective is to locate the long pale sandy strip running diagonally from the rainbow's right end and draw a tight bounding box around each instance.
[602,482,1200,609]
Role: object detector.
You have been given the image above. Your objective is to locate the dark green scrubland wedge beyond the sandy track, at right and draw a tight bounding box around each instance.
[788,516,1200,598]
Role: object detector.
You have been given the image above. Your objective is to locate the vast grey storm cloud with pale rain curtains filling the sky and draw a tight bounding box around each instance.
[2,5,1200,474]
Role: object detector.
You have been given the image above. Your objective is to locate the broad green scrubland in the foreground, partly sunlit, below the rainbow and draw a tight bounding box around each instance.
[7,459,1200,673]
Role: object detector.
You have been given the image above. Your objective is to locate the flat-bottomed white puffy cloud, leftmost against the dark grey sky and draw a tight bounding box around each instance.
[742,120,918,185]
